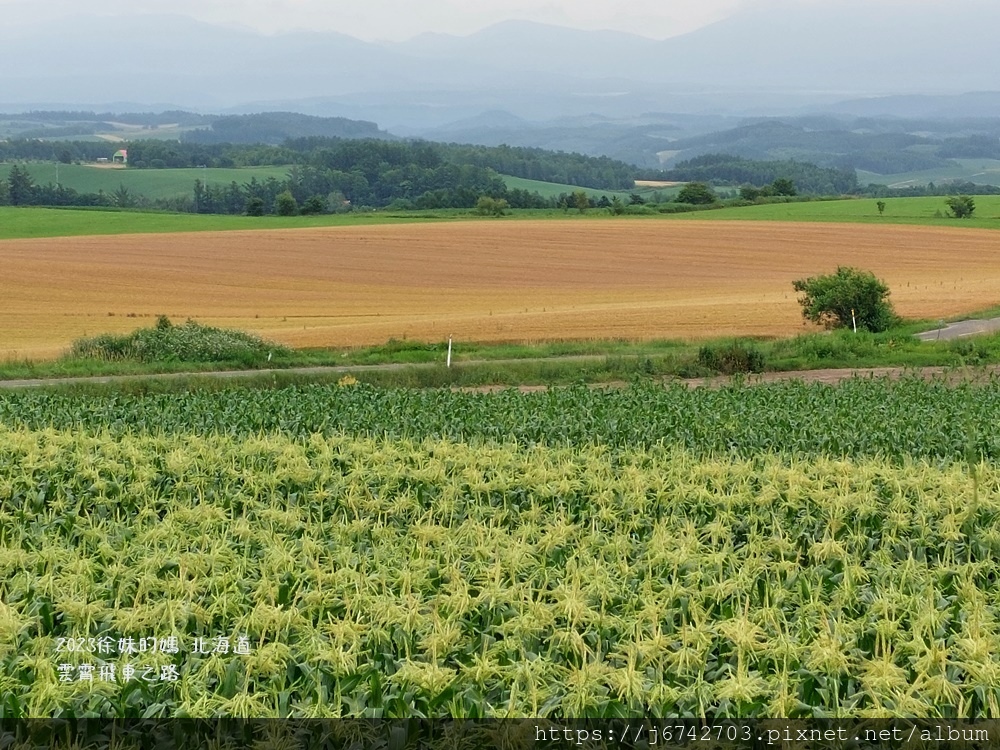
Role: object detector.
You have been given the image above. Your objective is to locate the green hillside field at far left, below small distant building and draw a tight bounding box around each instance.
[0,164,288,200]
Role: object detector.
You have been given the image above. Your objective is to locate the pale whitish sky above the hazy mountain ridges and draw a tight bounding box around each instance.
[0,0,756,41]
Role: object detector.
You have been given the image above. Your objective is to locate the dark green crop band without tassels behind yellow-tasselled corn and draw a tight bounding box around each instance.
[0,378,1000,459]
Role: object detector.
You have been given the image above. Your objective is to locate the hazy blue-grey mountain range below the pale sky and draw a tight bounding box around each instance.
[0,0,1000,125]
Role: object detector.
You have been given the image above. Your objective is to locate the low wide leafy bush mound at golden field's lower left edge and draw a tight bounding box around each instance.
[71,315,288,363]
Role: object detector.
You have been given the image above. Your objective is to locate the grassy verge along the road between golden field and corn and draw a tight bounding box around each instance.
[0,322,1000,387]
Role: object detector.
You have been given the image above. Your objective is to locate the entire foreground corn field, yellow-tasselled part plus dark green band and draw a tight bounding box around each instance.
[0,381,1000,718]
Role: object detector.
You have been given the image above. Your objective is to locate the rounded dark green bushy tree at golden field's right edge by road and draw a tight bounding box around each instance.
[792,266,898,333]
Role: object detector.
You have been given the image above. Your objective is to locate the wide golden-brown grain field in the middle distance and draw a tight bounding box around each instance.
[0,219,1000,358]
